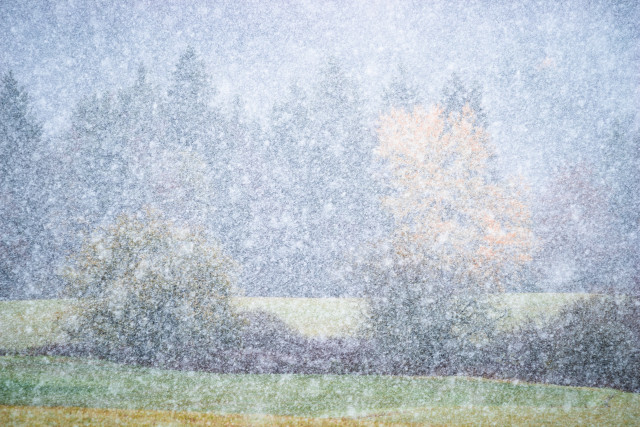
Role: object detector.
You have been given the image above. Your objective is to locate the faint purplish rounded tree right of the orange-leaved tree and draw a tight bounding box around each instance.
[536,164,631,292]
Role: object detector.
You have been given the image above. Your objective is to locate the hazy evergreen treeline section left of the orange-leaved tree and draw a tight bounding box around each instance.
[2,49,380,297]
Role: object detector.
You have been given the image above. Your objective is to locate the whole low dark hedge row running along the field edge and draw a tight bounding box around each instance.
[7,297,640,392]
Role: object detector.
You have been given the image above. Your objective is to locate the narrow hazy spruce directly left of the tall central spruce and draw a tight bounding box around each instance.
[264,85,321,295]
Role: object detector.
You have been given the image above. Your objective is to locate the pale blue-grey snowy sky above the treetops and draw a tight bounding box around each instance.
[0,0,640,174]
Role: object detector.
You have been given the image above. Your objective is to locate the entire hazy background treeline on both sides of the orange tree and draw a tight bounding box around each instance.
[0,49,640,298]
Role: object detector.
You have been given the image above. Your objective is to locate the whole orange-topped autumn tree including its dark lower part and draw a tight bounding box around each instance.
[358,106,532,374]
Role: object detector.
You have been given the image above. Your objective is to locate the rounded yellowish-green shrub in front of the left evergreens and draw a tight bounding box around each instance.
[65,211,239,365]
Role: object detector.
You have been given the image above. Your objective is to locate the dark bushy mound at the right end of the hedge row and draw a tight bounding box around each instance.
[484,297,640,392]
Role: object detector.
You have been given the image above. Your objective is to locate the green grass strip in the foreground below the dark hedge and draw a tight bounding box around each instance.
[0,357,640,425]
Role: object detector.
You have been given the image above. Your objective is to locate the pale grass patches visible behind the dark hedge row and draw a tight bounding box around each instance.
[0,293,589,350]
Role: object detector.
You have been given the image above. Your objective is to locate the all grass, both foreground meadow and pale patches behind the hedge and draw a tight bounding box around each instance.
[0,294,640,425]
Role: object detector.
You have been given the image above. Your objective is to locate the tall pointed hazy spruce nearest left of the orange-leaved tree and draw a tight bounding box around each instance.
[312,58,381,294]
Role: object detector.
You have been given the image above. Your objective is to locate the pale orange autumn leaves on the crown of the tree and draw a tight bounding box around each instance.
[375,106,533,290]
